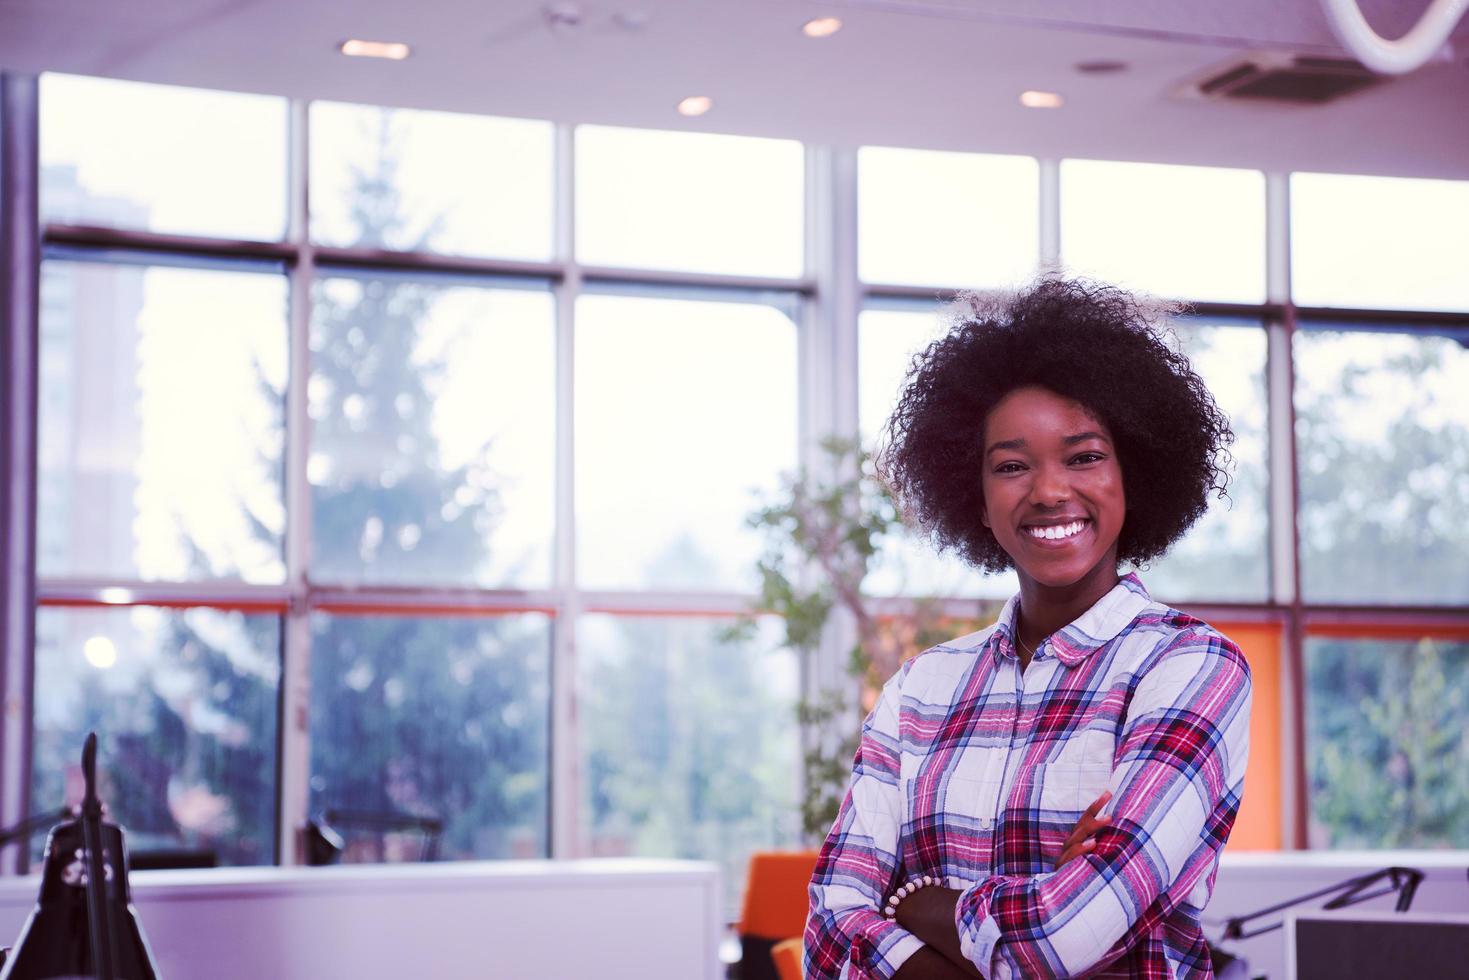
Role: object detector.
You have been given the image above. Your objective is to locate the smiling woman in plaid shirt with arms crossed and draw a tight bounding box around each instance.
[805,279,1250,980]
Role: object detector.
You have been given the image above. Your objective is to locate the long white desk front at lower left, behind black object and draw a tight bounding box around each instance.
[0,860,723,980]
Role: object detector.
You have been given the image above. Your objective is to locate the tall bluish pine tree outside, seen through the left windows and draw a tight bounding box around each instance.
[70,110,549,864]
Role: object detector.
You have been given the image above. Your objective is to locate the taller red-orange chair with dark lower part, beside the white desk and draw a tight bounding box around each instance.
[737,851,820,980]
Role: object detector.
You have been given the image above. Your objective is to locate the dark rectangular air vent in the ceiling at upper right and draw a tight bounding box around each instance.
[1178,51,1385,106]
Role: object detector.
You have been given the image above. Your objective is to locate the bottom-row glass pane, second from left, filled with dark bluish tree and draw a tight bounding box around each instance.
[310,613,551,861]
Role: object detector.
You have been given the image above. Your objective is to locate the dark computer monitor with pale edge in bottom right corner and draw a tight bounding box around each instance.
[1285,909,1469,980]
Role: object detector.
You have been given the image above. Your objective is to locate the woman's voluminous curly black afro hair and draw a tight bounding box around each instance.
[878,276,1234,572]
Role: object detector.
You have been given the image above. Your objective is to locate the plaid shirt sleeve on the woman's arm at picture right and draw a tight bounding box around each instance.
[955,629,1250,977]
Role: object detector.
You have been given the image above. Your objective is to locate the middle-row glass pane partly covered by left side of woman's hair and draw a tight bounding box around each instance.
[856,309,1019,598]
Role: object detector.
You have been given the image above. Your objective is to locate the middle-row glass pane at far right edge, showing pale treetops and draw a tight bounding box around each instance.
[1294,329,1469,605]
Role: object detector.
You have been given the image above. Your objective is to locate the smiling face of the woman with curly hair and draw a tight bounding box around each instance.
[981,388,1127,588]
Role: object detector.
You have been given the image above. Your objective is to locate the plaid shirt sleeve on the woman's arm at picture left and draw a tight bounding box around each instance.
[805,664,923,980]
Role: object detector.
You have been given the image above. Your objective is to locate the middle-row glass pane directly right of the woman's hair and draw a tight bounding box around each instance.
[1141,319,1271,602]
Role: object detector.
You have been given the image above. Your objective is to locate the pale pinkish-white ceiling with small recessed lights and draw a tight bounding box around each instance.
[0,0,1469,178]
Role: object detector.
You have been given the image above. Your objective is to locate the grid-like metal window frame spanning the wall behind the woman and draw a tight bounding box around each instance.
[0,75,1469,873]
